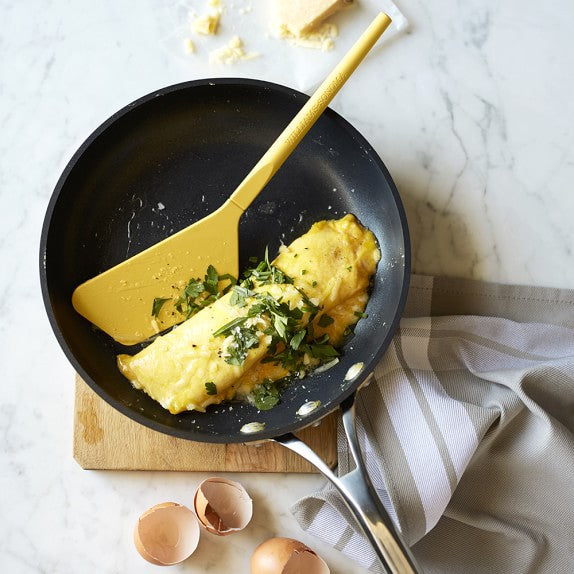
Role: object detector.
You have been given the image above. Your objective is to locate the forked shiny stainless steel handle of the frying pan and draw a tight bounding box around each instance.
[274,394,421,574]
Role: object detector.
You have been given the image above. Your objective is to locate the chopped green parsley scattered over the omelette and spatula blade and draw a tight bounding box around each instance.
[162,249,358,410]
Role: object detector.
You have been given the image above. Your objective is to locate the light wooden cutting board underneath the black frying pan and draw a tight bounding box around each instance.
[74,376,337,472]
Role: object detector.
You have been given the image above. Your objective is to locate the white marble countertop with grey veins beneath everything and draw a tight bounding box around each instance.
[0,0,574,574]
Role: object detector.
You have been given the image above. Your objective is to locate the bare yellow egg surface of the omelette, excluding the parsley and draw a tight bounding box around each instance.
[118,215,380,414]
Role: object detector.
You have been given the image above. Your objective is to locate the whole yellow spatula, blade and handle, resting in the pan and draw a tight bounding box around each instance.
[72,12,391,345]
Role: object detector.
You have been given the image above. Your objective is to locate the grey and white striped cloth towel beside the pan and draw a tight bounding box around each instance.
[292,276,574,574]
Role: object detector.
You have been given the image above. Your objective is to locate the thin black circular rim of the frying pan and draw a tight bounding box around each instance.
[39,77,411,443]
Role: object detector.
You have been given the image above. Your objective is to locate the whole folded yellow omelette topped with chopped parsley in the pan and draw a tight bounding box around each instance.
[118,215,380,414]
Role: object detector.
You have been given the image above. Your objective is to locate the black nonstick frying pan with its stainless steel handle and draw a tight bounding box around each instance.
[40,78,415,572]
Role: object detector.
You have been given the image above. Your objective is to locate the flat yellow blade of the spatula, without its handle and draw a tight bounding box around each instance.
[72,203,242,345]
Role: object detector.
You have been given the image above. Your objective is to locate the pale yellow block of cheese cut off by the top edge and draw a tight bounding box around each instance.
[273,0,353,36]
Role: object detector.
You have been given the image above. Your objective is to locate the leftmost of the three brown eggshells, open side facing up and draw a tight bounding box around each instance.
[134,502,199,566]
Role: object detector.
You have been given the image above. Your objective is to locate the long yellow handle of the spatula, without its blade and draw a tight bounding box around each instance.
[229,12,391,211]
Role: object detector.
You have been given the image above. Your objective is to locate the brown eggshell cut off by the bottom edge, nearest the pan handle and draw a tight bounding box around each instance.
[251,538,330,574]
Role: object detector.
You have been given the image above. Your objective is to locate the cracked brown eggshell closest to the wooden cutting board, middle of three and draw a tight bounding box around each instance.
[193,477,253,536]
